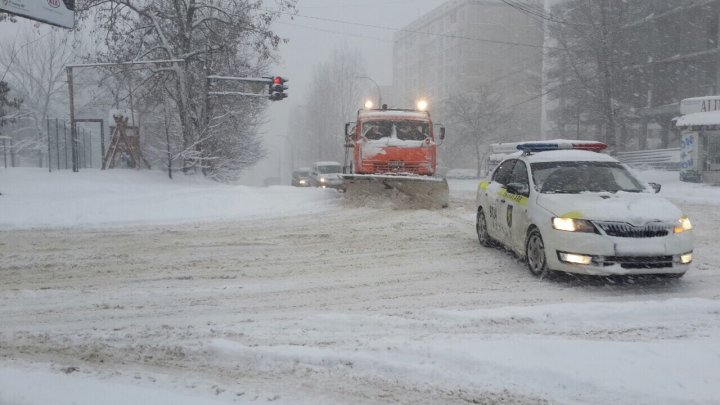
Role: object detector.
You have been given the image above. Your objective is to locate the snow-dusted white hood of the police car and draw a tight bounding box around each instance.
[537,191,682,226]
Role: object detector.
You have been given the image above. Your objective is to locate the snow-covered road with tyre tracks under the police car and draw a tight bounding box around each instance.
[0,169,720,405]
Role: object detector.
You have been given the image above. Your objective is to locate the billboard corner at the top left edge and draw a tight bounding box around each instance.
[0,0,75,28]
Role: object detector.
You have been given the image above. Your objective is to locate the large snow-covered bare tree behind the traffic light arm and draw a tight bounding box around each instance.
[81,0,295,179]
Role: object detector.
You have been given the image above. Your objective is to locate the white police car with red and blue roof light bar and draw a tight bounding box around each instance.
[476,141,693,277]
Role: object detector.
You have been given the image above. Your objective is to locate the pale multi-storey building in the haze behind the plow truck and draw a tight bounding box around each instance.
[393,0,543,166]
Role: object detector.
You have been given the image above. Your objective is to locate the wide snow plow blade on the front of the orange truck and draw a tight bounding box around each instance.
[343,174,450,209]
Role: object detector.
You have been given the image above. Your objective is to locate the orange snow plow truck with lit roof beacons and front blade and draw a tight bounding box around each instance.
[342,106,449,208]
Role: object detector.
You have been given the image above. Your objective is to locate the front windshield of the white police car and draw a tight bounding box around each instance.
[530,162,645,194]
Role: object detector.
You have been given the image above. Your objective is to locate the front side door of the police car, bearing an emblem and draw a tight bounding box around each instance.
[501,160,531,253]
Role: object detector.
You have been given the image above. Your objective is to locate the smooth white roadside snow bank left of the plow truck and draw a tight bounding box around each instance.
[0,168,339,229]
